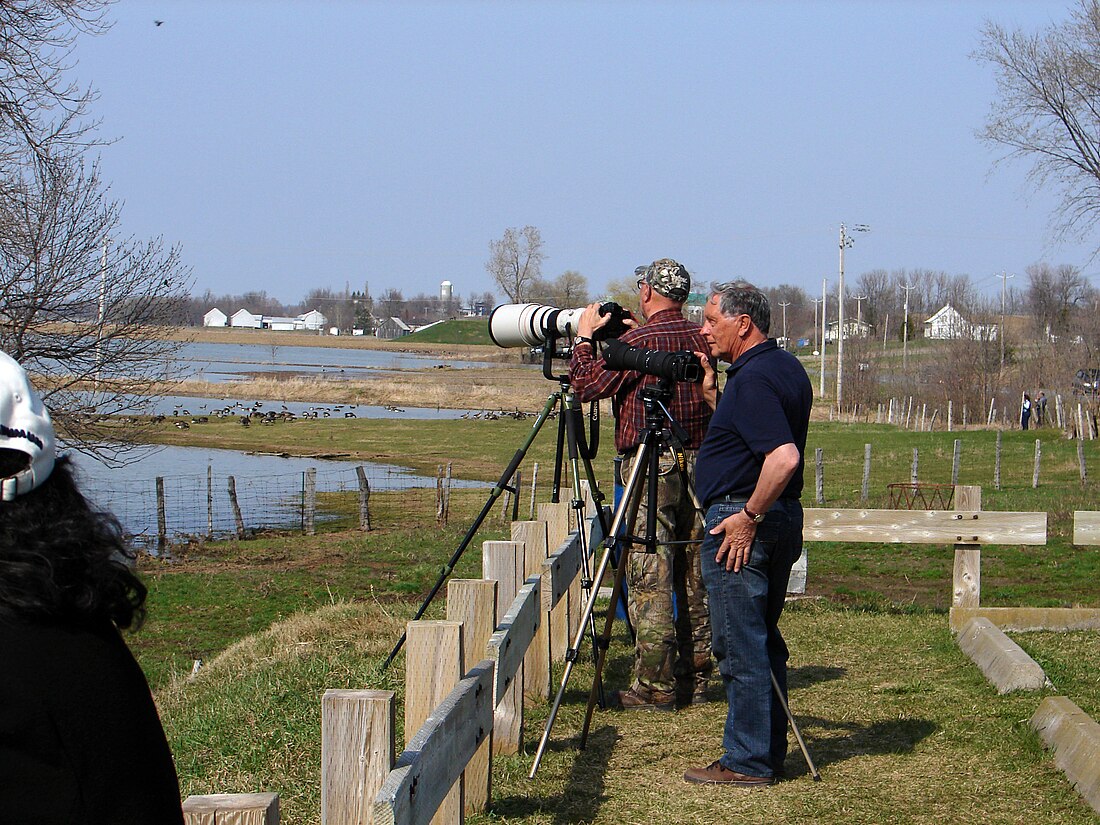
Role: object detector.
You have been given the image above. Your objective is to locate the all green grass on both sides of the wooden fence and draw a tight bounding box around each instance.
[130,419,1100,824]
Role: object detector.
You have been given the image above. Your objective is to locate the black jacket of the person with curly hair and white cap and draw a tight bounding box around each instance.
[0,619,184,825]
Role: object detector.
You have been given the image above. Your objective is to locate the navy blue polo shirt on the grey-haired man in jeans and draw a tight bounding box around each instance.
[695,338,813,506]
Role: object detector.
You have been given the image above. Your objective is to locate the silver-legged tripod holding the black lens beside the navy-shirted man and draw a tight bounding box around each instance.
[528,377,821,781]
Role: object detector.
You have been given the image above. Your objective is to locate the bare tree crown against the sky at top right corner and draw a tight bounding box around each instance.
[975,0,1100,251]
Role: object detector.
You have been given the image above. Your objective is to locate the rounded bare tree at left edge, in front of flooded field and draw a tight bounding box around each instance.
[0,157,190,460]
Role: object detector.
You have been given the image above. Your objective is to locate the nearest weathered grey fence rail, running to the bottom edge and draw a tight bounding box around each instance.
[374,660,493,825]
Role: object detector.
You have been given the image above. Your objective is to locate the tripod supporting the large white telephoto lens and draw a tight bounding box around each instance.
[382,339,633,673]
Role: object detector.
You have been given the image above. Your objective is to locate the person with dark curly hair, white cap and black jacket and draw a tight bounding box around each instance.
[0,352,184,825]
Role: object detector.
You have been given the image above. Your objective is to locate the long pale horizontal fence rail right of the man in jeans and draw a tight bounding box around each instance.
[803,507,1046,545]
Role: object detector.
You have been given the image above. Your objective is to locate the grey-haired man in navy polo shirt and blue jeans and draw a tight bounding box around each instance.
[684,282,813,788]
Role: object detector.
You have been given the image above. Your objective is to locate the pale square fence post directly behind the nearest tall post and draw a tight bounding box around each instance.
[405,620,466,825]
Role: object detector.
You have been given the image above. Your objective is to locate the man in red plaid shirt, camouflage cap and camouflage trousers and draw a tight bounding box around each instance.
[569,259,712,711]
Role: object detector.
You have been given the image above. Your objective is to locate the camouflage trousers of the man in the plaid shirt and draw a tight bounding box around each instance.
[622,451,712,695]
